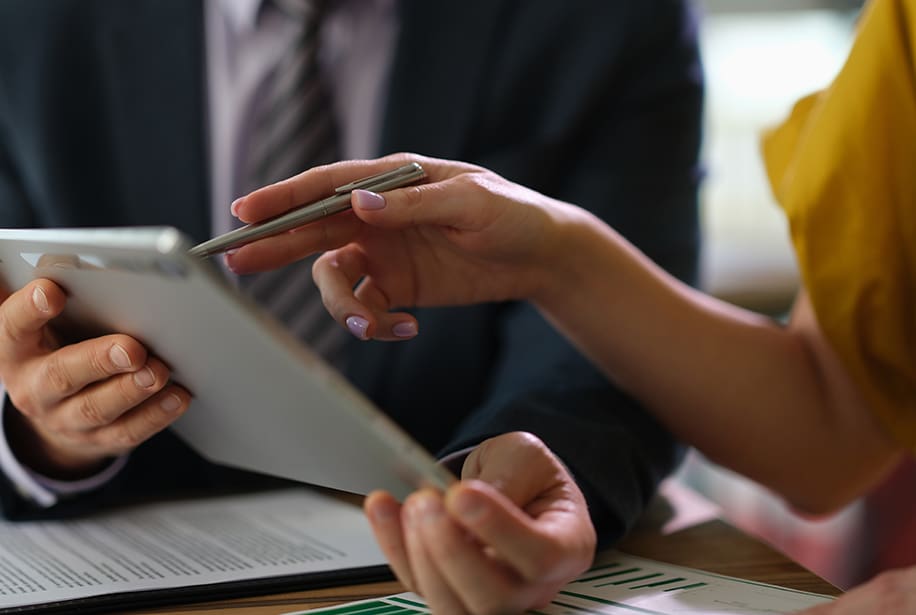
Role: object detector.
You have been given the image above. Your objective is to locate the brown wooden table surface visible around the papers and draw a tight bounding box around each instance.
[130,483,841,615]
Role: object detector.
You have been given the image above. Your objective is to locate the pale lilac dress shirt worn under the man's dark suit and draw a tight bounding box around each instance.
[0,0,398,507]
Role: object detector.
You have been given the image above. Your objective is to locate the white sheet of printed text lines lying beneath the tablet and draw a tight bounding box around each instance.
[0,489,385,608]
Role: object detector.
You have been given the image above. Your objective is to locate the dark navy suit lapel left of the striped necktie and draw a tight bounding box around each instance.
[102,0,210,239]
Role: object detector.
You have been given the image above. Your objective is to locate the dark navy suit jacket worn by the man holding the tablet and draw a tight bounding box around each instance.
[0,0,702,538]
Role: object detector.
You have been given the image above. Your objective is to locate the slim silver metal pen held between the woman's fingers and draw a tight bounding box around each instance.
[188,162,426,258]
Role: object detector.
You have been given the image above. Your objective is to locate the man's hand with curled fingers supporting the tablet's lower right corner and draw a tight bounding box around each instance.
[365,432,596,614]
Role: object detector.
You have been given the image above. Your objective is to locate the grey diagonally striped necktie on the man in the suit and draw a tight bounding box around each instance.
[240,0,346,367]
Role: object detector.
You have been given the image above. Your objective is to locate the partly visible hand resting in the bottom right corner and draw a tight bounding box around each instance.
[799,566,916,615]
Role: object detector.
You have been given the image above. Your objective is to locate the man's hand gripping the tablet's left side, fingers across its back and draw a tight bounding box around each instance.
[0,279,190,479]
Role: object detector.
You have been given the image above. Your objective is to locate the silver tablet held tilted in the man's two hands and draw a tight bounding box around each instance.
[0,227,454,498]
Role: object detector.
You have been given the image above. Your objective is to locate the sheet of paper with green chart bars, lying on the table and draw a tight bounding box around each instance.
[288,551,832,615]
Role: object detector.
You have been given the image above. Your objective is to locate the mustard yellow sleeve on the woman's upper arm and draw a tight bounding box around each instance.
[763,0,916,451]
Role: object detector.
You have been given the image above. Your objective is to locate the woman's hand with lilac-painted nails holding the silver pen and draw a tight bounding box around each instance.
[227,154,582,340]
